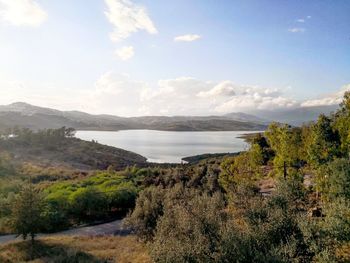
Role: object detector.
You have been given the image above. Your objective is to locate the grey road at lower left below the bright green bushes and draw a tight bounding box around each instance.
[0,220,125,244]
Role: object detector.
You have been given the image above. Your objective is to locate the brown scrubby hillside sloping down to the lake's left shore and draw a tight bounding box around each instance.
[0,129,147,170]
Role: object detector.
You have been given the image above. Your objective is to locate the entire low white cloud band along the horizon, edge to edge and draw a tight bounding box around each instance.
[0,71,350,116]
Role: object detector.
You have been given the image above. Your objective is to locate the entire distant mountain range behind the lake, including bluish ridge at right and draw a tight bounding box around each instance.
[0,102,338,131]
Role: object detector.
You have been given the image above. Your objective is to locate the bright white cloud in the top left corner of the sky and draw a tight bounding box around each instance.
[0,0,48,27]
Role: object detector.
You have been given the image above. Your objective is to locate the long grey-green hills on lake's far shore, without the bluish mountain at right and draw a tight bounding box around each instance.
[0,102,266,131]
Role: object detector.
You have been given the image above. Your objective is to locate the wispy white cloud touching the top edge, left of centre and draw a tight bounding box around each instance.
[105,0,158,42]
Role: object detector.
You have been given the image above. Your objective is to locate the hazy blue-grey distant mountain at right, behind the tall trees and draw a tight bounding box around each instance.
[251,105,339,126]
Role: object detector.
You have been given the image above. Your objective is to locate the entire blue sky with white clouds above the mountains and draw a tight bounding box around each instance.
[0,0,350,116]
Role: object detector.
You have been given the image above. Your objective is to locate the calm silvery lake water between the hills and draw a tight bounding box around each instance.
[76,130,256,163]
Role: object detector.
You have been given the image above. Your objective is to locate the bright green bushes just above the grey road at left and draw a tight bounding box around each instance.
[44,168,144,231]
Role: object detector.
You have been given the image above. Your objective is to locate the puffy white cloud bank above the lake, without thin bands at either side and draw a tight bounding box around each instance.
[85,72,298,116]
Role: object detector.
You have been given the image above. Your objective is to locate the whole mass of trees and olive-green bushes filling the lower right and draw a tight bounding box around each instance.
[126,93,350,262]
